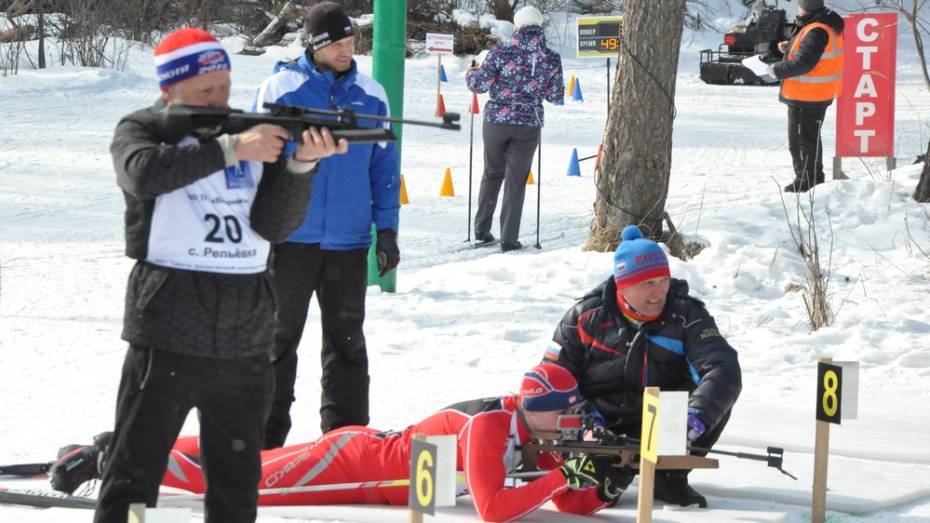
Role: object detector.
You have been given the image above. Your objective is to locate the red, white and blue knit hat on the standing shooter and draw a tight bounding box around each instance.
[155,27,230,91]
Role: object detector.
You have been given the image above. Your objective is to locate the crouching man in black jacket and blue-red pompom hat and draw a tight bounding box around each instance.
[545,225,742,507]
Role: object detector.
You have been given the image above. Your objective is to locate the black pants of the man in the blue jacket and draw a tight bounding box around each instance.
[265,242,370,448]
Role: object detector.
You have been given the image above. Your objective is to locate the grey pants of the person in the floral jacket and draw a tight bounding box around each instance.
[475,122,541,245]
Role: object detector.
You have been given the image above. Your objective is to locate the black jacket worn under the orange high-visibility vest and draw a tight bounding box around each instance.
[772,9,845,107]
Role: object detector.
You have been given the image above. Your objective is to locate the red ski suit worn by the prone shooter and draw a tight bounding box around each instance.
[163,396,609,521]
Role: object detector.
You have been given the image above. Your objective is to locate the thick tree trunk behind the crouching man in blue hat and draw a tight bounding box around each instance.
[585,0,685,251]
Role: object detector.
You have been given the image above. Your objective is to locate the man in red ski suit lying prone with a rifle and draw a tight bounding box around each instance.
[50,363,633,521]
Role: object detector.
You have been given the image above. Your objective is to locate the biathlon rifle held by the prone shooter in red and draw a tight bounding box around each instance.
[523,413,798,480]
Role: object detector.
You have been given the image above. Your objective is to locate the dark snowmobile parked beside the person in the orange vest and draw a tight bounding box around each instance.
[701,0,797,85]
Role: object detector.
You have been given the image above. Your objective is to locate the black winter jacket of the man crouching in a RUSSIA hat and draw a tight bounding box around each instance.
[546,277,742,434]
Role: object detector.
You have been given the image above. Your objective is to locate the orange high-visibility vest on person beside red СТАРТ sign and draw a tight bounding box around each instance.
[781,22,843,102]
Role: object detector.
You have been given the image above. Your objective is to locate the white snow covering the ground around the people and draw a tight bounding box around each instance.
[0,4,930,523]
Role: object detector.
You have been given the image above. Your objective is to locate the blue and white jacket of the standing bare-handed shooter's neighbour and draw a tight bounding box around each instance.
[253,53,400,251]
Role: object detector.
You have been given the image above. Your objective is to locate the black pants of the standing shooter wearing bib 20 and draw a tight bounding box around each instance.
[94,345,273,523]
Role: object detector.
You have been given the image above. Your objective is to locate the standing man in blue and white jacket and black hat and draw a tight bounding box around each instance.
[255,2,400,448]
